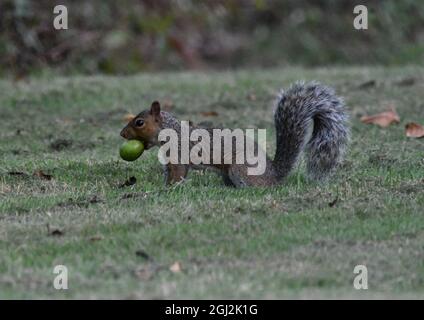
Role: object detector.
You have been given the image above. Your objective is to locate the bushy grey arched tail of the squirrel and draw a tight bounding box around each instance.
[273,82,349,180]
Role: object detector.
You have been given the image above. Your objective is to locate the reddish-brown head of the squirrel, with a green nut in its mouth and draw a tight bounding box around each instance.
[121,101,162,150]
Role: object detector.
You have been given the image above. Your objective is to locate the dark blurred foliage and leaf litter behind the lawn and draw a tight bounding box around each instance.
[0,0,424,76]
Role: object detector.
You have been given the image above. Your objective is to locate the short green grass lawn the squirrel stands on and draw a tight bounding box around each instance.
[0,67,424,299]
